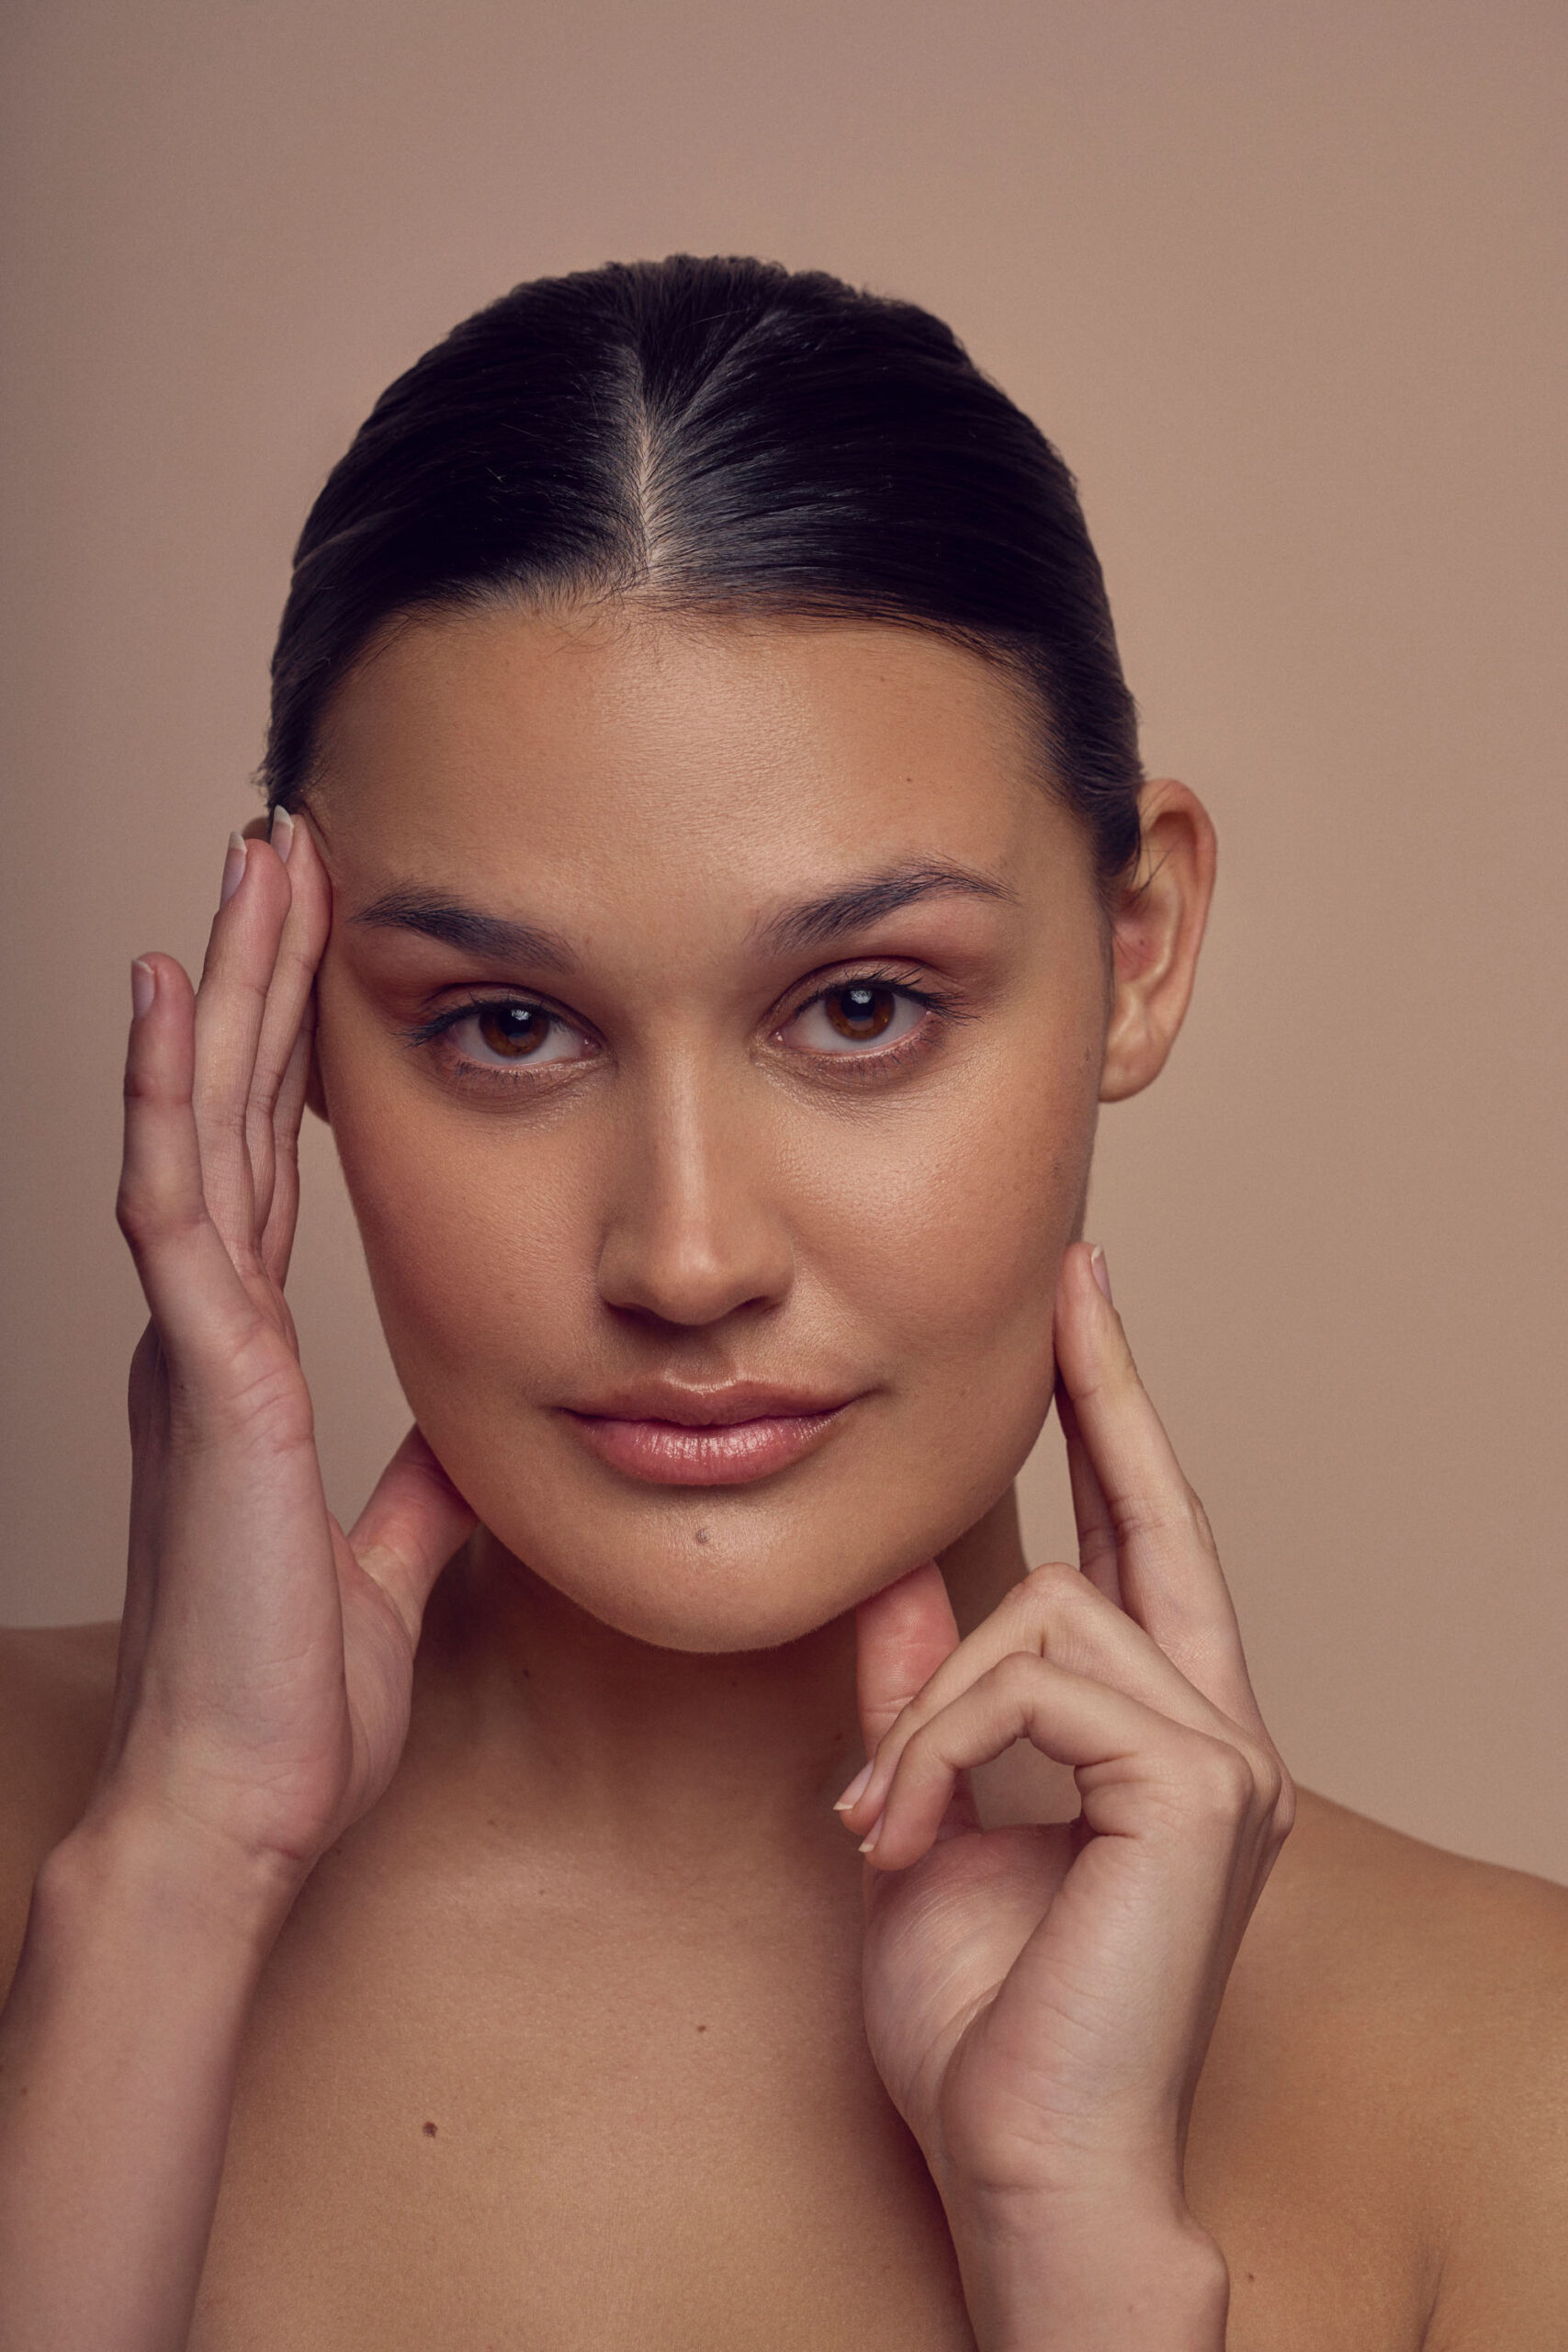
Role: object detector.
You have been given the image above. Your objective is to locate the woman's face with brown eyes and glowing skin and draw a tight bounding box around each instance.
[310,609,1112,1651]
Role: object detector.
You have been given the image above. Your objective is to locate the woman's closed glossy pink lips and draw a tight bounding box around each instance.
[562,1381,856,1487]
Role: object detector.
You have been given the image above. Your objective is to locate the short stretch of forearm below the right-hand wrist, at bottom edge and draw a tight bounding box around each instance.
[954,2206,1229,2352]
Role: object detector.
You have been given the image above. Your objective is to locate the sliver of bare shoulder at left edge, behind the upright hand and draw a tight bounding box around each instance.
[0,1625,120,1983]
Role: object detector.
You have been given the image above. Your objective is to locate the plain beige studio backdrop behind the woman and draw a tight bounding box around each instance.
[0,0,1568,1877]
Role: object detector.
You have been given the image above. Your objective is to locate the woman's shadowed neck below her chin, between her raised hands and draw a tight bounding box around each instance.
[416,1488,1025,1849]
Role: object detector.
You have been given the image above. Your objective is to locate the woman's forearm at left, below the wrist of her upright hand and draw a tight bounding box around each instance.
[0,1823,289,2352]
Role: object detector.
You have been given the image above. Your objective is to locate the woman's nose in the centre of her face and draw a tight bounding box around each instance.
[600,1080,795,1327]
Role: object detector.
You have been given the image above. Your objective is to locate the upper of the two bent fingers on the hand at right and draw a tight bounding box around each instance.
[844,1562,1236,1830]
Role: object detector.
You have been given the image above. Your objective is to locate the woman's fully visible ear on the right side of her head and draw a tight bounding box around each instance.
[1100,778,1215,1103]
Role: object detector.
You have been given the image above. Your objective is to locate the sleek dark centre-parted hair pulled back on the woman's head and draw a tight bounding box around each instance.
[264,254,1140,879]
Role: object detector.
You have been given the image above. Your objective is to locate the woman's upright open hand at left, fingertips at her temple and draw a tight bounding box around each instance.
[101,814,472,1898]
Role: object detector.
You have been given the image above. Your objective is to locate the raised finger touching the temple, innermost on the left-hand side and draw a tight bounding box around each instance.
[247,809,332,1268]
